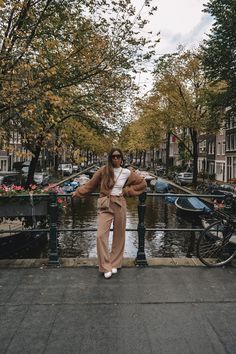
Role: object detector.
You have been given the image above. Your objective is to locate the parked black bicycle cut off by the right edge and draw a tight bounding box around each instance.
[197,194,236,267]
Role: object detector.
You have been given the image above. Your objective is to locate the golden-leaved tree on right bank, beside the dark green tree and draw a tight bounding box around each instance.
[150,48,213,183]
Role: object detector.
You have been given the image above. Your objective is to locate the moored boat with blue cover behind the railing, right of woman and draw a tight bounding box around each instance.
[175,196,212,215]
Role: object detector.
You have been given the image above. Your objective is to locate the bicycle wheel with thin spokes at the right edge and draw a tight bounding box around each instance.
[197,220,236,267]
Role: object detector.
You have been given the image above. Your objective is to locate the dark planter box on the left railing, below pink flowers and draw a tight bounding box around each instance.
[0,197,48,218]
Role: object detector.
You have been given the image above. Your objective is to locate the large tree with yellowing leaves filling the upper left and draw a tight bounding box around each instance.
[0,0,159,184]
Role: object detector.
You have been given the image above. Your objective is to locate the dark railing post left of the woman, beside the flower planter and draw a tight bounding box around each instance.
[48,193,60,266]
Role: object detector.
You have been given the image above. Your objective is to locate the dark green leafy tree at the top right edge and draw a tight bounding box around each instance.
[202,0,236,113]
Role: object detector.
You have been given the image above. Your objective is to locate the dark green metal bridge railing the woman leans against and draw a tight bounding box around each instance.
[0,193,230,267]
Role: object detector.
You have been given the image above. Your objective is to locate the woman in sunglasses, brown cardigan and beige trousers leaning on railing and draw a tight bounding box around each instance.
[72,148,146,279]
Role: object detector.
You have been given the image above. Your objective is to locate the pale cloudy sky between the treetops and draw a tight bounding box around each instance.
[132,0,213,92]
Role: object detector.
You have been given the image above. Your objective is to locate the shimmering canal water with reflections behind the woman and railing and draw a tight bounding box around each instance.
[59,196,199,258]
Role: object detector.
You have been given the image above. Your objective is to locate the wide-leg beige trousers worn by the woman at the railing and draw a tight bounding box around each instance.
[97,196,126,273]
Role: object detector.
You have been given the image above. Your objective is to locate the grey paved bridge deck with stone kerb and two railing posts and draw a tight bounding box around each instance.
[0,176,236,354]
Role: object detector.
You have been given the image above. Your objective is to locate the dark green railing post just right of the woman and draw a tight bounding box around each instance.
[135,192,148,267]
